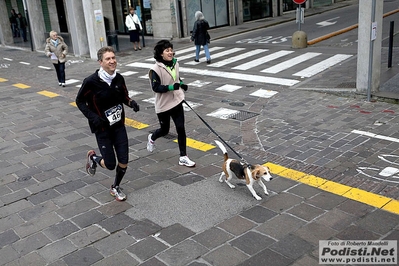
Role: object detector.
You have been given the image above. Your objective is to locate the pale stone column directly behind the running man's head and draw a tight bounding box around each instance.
[82,0,107,60]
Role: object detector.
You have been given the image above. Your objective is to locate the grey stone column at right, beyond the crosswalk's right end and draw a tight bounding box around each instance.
[356,0,383,93]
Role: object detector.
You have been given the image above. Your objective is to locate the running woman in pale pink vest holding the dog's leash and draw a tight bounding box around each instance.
[147,40,195,167]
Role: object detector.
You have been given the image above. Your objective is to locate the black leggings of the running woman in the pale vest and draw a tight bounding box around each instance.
[152,102,187,156]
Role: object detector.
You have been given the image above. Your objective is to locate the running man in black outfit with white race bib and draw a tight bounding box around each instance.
[76,46,140,201]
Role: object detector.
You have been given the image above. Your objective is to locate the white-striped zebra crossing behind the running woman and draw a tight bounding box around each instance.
[125,46,352,86]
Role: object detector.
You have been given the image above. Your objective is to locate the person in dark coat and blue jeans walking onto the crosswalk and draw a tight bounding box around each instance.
[190,11,211,64]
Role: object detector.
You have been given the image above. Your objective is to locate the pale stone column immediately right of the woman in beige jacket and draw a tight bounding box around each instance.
[65,0,89,56]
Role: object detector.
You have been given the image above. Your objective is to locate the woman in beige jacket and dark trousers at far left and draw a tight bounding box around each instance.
[44,30,68,87]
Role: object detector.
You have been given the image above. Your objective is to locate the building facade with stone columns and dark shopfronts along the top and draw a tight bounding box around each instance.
[0,0,342,59]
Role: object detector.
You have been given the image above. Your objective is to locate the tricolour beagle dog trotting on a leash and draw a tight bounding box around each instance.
[215,140,273,200]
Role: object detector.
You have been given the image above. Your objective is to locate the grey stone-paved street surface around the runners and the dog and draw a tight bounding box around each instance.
[0,1,399,266]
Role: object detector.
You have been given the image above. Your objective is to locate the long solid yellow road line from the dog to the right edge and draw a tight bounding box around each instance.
[264,163,399,214]
